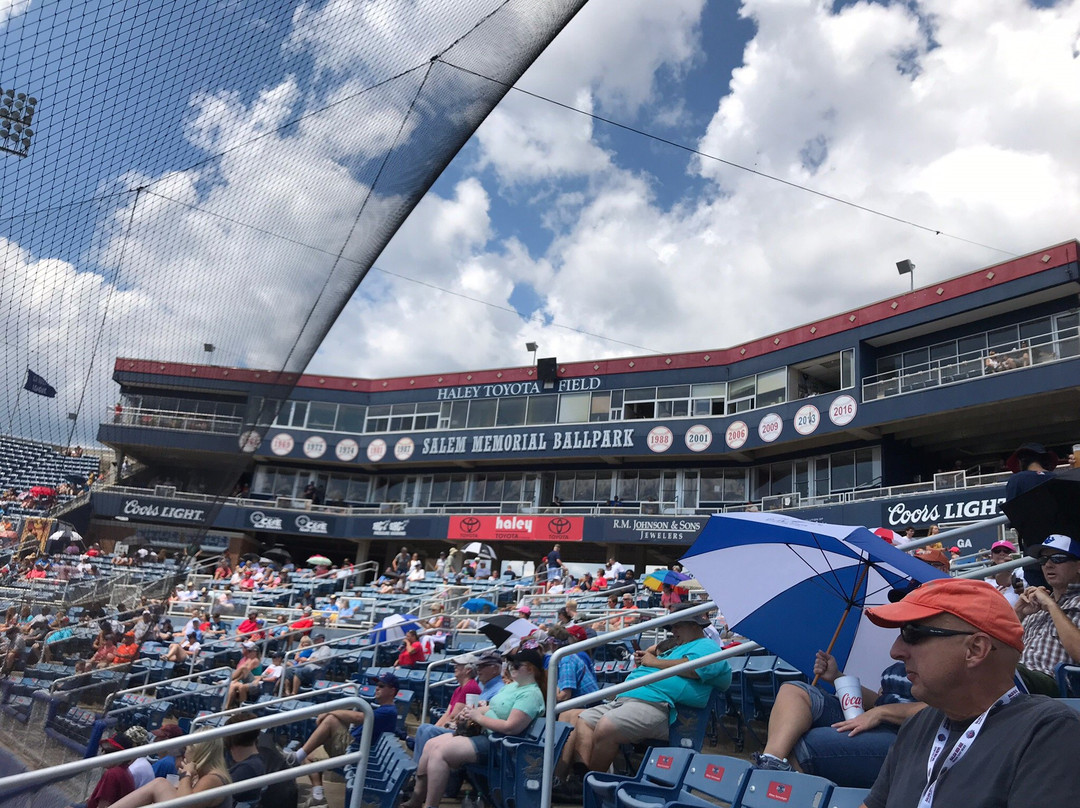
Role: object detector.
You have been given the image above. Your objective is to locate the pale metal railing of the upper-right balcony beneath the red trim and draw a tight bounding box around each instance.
[863,334,1080,402]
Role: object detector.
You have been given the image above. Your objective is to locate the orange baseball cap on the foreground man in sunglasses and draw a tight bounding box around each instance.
[866,578,1024,651]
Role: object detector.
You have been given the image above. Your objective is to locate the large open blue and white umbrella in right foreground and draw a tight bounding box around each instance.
[681,513,946,689]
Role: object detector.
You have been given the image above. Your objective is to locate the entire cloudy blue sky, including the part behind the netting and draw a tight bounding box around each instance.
[0,0,1080,442]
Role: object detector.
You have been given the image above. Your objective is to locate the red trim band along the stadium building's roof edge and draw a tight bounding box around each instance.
[114,240,1080,392]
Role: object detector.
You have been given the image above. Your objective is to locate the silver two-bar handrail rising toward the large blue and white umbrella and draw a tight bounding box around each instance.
[540,601,760,808]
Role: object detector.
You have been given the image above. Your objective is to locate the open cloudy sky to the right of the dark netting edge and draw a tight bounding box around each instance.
[311,0,1080,376]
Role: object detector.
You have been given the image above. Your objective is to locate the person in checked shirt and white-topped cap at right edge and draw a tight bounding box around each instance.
[1015,534,1080,677]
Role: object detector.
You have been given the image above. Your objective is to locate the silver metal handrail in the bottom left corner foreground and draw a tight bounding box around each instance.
[0,696,375,808]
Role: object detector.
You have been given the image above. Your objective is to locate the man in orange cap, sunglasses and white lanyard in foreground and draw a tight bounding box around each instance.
[865,579,1080,808]
